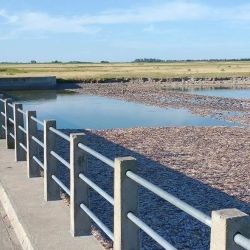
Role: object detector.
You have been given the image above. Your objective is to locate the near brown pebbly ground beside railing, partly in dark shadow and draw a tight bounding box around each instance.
[41,127,250,250]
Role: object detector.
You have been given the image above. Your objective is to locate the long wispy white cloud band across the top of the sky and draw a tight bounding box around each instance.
[0,1,250,36]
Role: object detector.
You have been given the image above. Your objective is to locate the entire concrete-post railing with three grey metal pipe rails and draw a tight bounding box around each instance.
[0,96,250,250]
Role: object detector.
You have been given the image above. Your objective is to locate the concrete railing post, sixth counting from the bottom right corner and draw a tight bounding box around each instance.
[14,104,26,161]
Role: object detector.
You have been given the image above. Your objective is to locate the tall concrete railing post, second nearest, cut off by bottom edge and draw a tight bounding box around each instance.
[114,157,140,250]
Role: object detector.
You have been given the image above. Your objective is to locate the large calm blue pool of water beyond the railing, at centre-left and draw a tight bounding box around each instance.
[9,91,235,129]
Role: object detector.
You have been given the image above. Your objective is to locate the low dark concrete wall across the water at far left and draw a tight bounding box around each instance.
[0,76,56,90]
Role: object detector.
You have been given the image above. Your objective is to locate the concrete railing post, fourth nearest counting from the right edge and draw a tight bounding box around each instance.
[44,120,61,201]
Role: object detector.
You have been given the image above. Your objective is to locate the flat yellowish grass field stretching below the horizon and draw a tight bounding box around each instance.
[0,61,250,80]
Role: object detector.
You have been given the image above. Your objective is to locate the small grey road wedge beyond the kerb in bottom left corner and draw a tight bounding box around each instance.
[0,203,22,250]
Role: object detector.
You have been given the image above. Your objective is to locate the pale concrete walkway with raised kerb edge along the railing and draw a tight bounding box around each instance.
[0,140,103,250]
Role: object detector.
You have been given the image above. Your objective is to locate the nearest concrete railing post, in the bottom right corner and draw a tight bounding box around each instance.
[210,208,250,250]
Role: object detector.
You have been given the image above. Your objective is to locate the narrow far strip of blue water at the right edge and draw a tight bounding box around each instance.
[189,89,250,99]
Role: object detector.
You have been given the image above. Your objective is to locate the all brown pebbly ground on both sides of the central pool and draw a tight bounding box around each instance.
[42,79,250,250]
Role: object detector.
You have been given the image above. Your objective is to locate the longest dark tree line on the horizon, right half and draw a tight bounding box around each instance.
[132,58,250,63]
